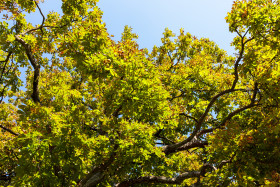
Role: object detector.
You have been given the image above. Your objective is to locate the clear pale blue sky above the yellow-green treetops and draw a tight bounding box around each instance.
[28,0,234,54]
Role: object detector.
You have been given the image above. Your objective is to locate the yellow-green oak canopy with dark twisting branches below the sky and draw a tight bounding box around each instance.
[0,0,280,187]
